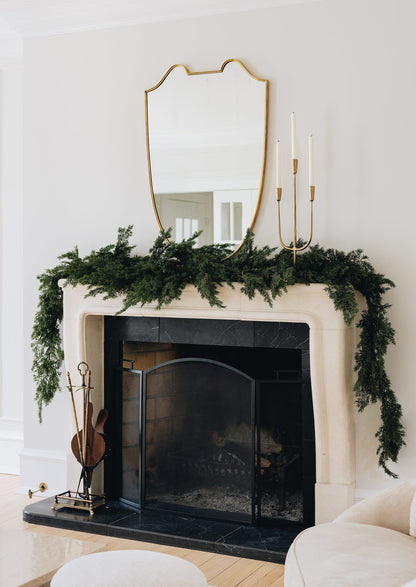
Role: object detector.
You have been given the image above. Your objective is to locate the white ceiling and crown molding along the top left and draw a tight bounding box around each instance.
[0,0,316,54]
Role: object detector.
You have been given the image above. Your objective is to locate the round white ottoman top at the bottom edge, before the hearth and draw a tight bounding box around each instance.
[51,550,208,587]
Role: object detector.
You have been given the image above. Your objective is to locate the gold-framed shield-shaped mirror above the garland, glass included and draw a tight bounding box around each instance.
[145,59,268,258]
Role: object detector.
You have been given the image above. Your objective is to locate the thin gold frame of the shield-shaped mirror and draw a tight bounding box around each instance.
[144,59,269,259]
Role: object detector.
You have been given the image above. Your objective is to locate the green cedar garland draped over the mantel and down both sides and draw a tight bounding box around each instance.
[32,226,405,477]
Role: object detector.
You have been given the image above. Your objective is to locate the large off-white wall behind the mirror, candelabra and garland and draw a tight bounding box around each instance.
[22,0,416,492]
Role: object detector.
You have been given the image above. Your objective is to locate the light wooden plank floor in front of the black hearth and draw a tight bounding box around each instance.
[0,475,284,587]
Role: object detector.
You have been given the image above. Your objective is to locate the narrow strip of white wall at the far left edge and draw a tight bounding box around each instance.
[0,58,23,473]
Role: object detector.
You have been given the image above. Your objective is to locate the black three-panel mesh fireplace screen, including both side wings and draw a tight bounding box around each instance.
[120,347,315,523]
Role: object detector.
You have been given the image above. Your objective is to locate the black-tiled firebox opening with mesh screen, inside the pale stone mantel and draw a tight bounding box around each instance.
[105,318,315,525]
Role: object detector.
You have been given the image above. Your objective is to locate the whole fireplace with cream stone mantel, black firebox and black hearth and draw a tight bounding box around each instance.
[24,282,361,562]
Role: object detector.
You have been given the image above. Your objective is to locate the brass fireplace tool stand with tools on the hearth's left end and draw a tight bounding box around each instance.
[52,362,108,516]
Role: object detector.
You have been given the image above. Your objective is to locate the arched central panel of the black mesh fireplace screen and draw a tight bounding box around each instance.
[142,359,256,520]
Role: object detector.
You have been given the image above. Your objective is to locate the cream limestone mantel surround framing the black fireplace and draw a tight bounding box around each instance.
[62,284,357,523]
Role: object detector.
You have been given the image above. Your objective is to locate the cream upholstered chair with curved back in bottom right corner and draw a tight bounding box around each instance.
[285,480,416,587]
